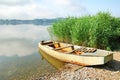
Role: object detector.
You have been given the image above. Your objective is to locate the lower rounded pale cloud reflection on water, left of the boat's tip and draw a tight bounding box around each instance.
[0,38,37,56]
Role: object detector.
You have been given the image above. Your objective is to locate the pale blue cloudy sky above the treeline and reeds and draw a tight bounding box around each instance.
[0,0,120,20]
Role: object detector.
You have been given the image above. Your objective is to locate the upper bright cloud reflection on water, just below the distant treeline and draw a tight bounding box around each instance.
[0,25,49,41]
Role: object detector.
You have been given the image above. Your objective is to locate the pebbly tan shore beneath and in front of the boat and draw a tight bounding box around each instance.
[32,52,120,80]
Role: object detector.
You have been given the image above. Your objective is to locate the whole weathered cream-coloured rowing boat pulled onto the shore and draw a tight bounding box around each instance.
[39,41,113,65]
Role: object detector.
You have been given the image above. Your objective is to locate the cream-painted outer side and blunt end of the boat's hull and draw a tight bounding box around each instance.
[39,43,113,65]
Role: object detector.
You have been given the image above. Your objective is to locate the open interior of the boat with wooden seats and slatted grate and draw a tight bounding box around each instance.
[41,41,97,54]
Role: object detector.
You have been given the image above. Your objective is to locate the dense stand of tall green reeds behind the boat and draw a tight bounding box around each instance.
[49,12,120,50]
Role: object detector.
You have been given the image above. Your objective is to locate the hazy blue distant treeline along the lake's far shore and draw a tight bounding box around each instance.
[0,18,64,25]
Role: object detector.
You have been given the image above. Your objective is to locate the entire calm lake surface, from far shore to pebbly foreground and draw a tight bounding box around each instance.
[0,25,56,80]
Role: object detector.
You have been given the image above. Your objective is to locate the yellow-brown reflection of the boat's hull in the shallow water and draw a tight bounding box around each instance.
[39,49,65,69]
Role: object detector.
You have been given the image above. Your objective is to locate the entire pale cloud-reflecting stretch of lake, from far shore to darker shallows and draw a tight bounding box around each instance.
[0,25,49,56]
